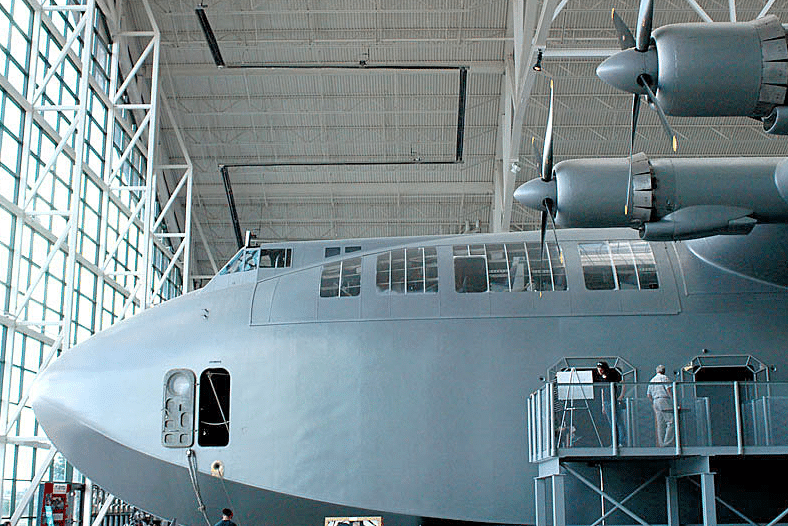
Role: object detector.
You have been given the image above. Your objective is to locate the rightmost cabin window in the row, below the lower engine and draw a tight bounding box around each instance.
[577,241,659,290]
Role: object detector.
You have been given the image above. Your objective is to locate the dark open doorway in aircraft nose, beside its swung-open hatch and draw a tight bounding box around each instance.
[197,368,230,446]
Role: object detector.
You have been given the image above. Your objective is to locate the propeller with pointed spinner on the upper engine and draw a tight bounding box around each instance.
[608,0,678,215]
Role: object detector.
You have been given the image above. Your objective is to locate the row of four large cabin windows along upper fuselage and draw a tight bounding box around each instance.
[320,241,659,298]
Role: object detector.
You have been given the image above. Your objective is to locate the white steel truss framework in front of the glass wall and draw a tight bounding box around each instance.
[0,0,192,526]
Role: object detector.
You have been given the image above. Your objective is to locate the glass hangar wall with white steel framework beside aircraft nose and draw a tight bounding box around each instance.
[0,0,191,525]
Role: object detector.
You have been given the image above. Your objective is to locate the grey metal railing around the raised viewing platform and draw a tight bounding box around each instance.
[527,381,788,462]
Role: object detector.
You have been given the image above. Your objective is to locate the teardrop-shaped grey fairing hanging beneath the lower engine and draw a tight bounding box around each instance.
[639,206,758,241]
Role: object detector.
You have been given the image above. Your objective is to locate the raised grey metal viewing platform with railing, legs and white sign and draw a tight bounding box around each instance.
[527,380,788,526]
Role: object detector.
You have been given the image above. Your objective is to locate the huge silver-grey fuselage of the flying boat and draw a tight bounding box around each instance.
[33,229,788,526]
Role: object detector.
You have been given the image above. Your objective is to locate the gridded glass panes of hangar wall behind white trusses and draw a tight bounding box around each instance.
[0,0,182,525]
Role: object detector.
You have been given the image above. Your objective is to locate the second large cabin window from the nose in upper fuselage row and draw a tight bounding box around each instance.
[375,247,438,294]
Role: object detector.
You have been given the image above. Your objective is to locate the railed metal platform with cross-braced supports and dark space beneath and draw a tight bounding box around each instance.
[527,379,788,526]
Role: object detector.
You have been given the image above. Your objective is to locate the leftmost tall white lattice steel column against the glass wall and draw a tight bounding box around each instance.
[0,0,95,526]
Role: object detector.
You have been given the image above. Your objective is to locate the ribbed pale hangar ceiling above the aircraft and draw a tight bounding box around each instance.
[124,0,788,284]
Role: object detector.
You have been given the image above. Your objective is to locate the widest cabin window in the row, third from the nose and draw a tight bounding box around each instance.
[453,242,566,292]
